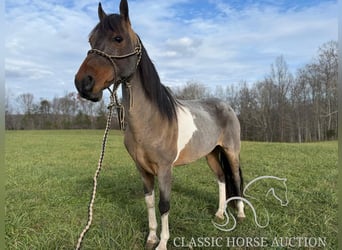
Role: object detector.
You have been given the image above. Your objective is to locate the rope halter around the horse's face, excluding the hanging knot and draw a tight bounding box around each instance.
[88,38,142,89]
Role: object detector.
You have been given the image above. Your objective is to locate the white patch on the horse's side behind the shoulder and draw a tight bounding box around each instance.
[174,107,197,162]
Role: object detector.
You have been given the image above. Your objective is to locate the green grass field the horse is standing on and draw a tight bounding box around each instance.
[5,130,338,250]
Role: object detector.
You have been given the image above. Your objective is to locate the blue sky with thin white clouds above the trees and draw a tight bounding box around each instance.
[4,0,338,99]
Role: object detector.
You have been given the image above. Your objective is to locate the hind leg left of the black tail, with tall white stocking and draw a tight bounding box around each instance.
[206,148,226,220]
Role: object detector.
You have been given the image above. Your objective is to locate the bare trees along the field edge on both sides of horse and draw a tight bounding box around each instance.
[6,41,338,142]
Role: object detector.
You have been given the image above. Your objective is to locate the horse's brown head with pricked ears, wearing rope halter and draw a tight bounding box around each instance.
[75,0,141,102]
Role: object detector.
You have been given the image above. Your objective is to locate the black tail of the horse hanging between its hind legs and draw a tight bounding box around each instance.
[219,149,243,205]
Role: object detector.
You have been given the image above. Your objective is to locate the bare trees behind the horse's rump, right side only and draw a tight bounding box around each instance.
[176,41,338,142]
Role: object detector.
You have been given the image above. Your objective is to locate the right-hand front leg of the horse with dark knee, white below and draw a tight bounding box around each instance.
[156,167,171,250]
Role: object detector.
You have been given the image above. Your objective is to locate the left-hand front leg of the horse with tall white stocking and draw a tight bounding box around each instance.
[139,168,159,249]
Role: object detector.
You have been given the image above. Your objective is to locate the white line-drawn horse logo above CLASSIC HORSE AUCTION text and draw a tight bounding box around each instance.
[213,176,289,232]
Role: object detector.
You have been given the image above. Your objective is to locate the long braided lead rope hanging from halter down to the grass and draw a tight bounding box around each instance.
[76,86,117,250]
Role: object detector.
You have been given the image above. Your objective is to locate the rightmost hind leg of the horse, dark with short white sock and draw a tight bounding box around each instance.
[224,149,246,220]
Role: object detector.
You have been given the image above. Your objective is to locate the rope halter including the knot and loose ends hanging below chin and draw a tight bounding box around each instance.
[88,39,142,130]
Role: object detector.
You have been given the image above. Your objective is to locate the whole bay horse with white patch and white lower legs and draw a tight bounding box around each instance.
[75,0,245,250]
